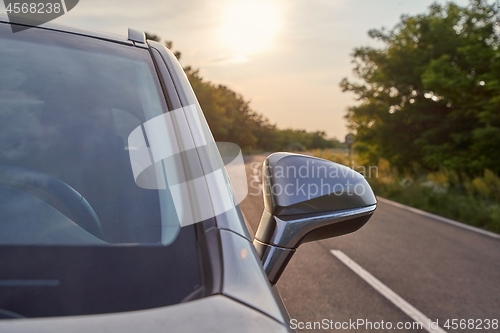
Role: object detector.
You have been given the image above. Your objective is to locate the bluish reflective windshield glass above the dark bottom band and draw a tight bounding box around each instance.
[0,26,185,245]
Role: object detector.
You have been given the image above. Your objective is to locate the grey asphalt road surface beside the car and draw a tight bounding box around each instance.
[241,156,500,332]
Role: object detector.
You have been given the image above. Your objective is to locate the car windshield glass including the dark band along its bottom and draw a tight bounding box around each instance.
[0,23,202,319]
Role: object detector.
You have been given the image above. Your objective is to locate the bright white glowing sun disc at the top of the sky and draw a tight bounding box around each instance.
[220,0,279,56]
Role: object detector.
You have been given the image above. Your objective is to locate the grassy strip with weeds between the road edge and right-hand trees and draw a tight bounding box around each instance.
[309,150,500,233]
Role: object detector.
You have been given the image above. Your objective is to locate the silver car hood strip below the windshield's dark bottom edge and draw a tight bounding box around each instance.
[0,295,289,333]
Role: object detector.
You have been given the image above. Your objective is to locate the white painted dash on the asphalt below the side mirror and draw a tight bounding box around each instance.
[330,250,446,333]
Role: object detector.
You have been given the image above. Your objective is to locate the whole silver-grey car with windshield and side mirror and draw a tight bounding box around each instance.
[0,17,376,333]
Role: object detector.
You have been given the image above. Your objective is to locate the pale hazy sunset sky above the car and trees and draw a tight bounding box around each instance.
[0,0,467,141]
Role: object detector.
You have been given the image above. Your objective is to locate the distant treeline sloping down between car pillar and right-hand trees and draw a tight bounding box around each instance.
[146,34,343,152]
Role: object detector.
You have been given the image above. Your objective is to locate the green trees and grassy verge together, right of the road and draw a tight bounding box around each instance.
[336,0,500,232]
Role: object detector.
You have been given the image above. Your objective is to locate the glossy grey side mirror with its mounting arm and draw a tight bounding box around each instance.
[253,153,377,284]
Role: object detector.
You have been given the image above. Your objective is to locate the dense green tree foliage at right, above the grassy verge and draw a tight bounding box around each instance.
[340,0,500,174]
